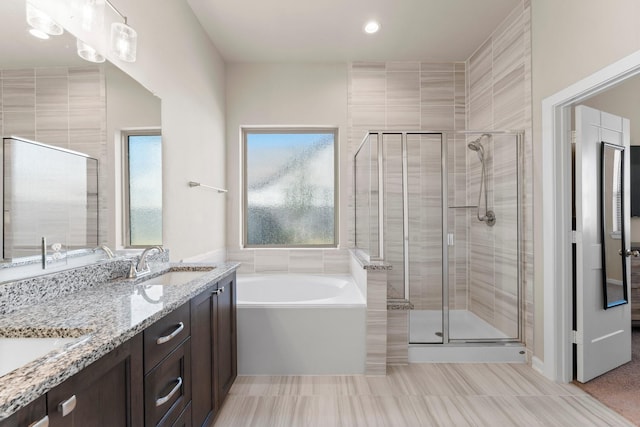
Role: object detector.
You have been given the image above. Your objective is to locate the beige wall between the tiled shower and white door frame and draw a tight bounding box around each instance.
[531,0,640,359]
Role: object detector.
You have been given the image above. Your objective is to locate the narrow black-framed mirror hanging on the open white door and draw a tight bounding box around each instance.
[600,142,631,310]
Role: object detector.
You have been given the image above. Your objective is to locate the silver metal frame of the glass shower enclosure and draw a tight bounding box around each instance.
[354,130,525,346]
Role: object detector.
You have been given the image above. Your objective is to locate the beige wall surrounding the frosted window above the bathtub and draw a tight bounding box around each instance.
[226,63,353,273]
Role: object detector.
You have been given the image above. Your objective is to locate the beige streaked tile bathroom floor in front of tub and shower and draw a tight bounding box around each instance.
[215,363,633,427]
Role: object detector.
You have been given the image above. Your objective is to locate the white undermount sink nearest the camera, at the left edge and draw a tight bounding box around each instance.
[0,329,89,377]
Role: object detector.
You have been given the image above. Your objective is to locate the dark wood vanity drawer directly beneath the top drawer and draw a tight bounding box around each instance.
[144,338,191,426]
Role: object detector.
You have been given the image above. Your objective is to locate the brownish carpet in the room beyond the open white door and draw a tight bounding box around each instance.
[574,328,640,426]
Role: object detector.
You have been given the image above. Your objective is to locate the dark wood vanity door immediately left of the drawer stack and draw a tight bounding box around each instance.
[47,335,144,427]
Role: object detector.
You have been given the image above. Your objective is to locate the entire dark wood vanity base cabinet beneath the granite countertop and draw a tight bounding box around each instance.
[0,273,237,427]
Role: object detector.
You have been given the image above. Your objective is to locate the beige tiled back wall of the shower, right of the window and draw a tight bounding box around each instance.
[349,62,466,309]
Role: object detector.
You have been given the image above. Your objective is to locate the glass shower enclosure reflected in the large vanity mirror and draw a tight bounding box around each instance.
[2,137,98,262]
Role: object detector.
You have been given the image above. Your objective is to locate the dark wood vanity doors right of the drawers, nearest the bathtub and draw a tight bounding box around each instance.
[191,273,237,426]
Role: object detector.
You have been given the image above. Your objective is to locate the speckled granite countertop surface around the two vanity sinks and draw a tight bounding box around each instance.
[0,263,239,420]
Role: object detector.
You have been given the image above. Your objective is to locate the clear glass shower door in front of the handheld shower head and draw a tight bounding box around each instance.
[448,134,520,342]
